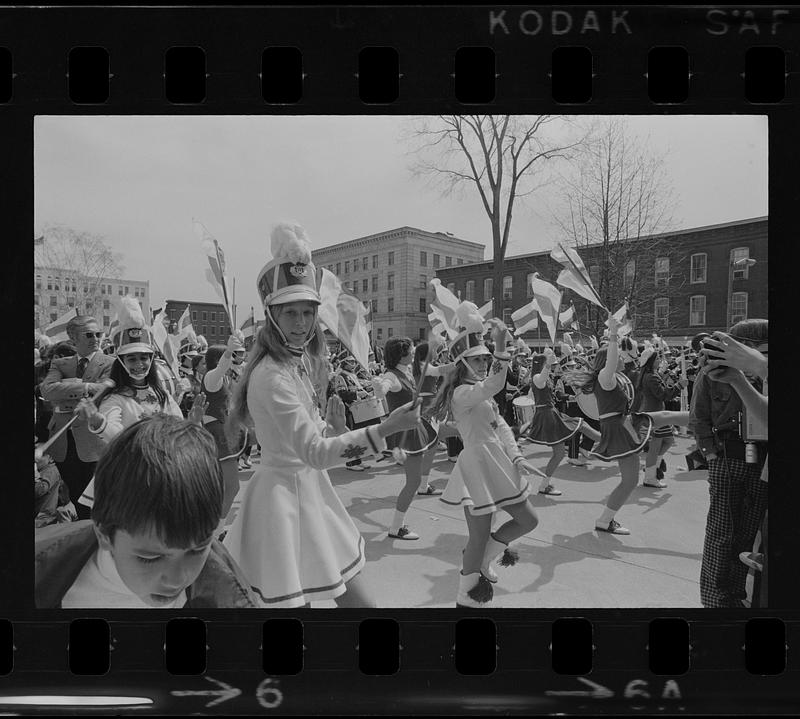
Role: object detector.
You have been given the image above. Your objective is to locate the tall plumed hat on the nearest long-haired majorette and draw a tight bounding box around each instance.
[256,222,321,307]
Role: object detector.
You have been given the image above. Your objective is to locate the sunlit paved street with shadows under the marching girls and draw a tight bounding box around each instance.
[228,437,708,608]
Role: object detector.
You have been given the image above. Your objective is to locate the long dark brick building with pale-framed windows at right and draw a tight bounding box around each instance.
[436,217,769,345]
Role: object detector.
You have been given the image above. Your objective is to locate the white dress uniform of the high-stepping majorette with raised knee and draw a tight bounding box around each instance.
[439,360,530,514]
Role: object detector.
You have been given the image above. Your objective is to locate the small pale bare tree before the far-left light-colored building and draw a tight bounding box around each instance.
[34,225,124,324]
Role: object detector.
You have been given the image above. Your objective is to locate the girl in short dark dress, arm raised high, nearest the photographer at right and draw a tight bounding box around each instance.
[570,314,653,534]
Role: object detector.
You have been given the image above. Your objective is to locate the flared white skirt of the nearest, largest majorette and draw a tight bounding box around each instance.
[224,460,365,607]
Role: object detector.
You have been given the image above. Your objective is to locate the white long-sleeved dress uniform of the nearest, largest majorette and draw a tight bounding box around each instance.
[219,357,385,607]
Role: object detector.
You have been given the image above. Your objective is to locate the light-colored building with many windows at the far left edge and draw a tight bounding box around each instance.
[33,266,150,330]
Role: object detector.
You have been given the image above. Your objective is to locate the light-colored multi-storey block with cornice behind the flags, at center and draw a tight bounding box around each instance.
[311,227,486,346]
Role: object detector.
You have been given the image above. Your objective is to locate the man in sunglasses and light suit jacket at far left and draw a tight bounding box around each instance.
[42,315,116,519]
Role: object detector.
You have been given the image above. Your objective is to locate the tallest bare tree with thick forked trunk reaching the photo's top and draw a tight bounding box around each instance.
[407,115,583,317]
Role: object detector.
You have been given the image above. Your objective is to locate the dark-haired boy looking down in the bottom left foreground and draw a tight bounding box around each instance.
[35,415,257,609]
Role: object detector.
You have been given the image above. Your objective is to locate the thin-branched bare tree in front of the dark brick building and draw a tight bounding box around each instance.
[553,118,688,332]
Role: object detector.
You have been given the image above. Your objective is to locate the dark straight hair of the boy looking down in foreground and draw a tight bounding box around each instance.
[92,415,223,548]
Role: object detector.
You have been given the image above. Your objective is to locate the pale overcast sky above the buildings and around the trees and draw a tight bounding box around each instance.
[34,116,768,323]
